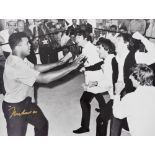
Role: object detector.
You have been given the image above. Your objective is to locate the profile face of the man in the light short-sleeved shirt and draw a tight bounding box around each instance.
[17,37,30,56]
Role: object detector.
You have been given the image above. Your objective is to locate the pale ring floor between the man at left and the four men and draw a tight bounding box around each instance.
[0,74,129,136]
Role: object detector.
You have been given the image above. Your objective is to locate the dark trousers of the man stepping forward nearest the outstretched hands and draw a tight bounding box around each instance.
[80,91,105,129]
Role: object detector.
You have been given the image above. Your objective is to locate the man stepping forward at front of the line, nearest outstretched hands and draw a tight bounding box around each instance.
[73,31,105,134]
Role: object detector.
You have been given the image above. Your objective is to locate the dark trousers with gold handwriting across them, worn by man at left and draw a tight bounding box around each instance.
[2,97,48,136]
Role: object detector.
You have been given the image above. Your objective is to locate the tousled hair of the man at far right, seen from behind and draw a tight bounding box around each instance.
[131,64,154,86]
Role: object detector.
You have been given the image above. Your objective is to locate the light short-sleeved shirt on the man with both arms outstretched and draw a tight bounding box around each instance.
[4,55,40,103]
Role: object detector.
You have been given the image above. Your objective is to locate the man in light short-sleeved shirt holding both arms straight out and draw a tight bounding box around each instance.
[2,32,81,136]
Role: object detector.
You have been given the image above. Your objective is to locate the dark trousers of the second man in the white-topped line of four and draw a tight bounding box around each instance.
[96,100,113,136]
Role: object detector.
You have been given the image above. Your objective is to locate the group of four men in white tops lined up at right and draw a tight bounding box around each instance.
[73,28,155,136]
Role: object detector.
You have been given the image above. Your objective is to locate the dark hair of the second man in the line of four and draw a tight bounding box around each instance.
[96,37,116,55]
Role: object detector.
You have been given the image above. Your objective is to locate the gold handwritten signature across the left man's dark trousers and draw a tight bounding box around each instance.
[9,107,38,118]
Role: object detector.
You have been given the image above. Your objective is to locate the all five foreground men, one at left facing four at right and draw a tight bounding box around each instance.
[2,19,155,136]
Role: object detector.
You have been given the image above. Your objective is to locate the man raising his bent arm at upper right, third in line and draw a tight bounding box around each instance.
[110,32,155,136]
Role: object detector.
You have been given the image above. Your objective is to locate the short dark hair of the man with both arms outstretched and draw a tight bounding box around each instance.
[9,32,27,50]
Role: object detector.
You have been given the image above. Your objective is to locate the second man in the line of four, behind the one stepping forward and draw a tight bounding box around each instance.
[96,38,118,136]
